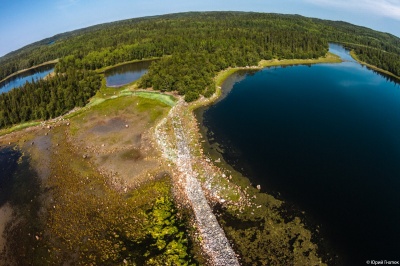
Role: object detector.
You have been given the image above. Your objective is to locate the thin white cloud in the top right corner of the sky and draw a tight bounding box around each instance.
[305,0,400,20]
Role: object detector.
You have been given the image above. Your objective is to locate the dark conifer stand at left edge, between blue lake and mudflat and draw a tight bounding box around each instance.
[0,68,101,128]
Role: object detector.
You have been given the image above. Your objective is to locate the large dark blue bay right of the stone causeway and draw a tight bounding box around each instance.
[203,45,400,265]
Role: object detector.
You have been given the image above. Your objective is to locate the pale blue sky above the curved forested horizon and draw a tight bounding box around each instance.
[0,0,400,56]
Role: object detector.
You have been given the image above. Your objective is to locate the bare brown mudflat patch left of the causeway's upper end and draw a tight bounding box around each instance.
[68,99,168,190]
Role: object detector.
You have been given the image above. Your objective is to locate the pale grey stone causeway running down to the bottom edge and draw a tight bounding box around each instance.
[155,101,239,265]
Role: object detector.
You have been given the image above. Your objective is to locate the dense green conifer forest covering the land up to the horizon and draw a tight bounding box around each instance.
[0,12,400,126]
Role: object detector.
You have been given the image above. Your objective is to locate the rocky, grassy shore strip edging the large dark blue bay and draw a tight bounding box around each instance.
[188,53,343,265]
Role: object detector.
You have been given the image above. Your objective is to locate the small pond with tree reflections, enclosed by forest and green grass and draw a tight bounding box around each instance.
[105,60,153,87]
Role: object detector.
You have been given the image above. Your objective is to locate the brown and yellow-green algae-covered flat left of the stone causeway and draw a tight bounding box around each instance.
[0,86,195,265]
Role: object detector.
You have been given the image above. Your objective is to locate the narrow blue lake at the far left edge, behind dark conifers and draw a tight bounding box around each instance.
[0,65,54,94]
